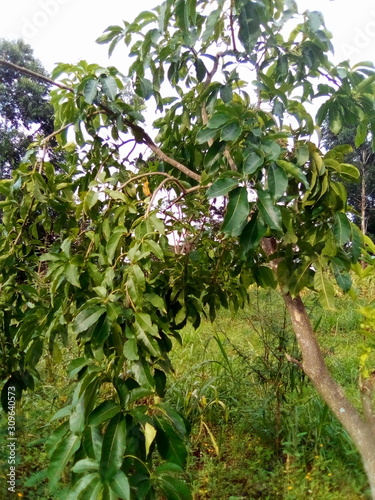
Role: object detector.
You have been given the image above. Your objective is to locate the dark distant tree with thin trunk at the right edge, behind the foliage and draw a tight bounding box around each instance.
[322,126,375,236]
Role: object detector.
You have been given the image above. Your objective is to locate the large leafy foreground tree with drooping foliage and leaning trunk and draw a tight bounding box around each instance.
[0,0,375,499]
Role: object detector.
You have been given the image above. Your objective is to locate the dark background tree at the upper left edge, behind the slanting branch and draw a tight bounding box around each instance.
[0,39,53,179]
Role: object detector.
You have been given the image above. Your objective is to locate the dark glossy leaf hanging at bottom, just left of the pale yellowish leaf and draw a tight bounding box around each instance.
[99,414,126,482]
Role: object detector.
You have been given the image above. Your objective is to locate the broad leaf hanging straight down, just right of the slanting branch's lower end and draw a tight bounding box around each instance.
[221,187,249,236]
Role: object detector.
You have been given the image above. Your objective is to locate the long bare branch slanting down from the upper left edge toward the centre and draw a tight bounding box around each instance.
[0,59,201,182]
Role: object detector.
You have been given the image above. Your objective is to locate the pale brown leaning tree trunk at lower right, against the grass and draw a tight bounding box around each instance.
[283,293,375,500]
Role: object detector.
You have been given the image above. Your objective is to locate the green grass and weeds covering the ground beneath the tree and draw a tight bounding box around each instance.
[0,283,375,500]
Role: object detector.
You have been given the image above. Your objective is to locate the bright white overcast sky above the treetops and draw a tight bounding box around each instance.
[0,0,375,71]
